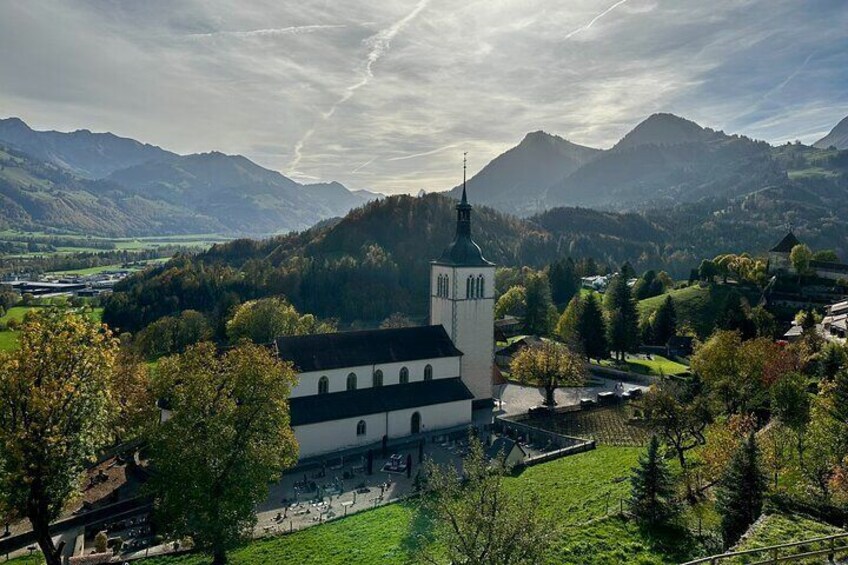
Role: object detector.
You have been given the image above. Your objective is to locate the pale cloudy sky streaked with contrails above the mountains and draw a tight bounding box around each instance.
[0,0,848,193]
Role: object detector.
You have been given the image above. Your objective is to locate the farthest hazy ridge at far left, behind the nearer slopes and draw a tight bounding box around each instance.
[0,118,176,179]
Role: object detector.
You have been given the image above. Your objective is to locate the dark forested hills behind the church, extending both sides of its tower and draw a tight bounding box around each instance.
[105,187,845,334]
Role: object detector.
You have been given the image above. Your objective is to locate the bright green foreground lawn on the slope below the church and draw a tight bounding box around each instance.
[143,446,699,565]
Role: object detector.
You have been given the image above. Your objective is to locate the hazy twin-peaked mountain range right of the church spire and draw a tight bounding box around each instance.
[451,114,816,216]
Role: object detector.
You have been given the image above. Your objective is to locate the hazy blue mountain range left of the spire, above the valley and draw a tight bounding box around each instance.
[0,118,380,236]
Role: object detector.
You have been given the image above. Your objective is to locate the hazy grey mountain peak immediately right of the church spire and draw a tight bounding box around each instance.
[451,131,601,213]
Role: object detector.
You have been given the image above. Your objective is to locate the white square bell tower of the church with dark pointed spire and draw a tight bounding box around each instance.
[430,156,495,406]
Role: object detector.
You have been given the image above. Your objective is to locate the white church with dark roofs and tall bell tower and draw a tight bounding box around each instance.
[276,187,495,459]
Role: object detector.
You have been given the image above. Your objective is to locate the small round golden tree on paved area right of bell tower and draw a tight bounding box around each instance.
[510,341,585,408]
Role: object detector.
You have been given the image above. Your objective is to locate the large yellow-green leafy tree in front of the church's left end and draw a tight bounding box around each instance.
[151,342,298,565]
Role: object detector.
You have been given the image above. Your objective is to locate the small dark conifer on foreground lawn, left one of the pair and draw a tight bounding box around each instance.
[630,436,678,525]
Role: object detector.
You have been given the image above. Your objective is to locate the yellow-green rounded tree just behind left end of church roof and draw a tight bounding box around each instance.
[227,298,335,344]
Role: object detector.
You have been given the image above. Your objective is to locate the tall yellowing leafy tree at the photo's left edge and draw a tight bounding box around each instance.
[0,313,118,565]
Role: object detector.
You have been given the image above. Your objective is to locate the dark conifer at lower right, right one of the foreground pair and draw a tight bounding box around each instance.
[716,433,766,547]
